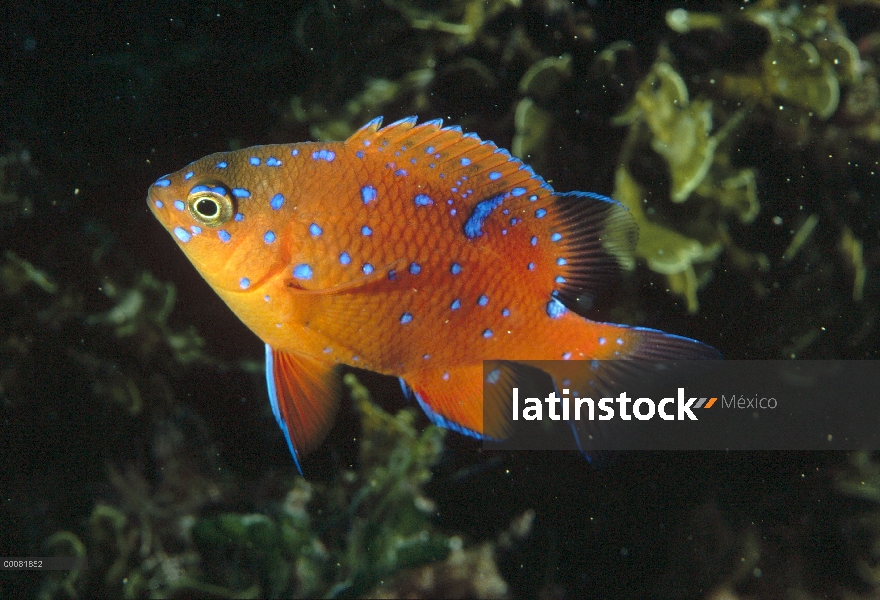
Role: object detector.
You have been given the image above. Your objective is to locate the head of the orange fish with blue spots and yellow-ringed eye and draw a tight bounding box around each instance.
[147,151,286,293]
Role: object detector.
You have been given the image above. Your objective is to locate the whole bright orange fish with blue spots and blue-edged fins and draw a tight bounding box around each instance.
[147,117,718,468]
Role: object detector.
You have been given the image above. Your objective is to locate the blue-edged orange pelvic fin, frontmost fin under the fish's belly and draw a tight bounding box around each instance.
[266,344,340,474]
